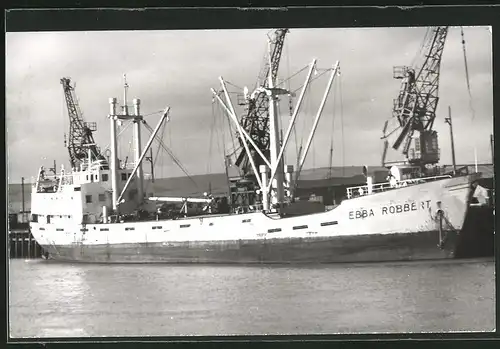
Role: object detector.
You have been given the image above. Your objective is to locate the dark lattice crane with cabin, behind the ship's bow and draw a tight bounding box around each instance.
[382,27,448,172]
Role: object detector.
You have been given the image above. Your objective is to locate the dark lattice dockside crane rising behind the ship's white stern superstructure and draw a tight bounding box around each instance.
[61,78,105,168]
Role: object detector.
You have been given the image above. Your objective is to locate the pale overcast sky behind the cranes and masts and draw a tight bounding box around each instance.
[6,27,493,182]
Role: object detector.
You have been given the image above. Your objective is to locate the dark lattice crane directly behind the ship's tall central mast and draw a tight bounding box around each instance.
[235,29,288,177]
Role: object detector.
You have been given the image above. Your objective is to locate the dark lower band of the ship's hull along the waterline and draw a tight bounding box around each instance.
[41,231,456,264]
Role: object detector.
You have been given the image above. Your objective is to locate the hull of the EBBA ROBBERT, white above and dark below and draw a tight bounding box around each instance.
[31,175,475,263]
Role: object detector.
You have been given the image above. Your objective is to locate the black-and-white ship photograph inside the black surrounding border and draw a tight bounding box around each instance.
[5,8,496,339]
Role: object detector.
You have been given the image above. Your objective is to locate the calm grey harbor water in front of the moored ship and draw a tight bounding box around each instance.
[9,258,495,338]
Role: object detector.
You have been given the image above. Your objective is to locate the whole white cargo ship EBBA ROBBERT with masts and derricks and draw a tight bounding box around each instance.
[30,27,486,264]
